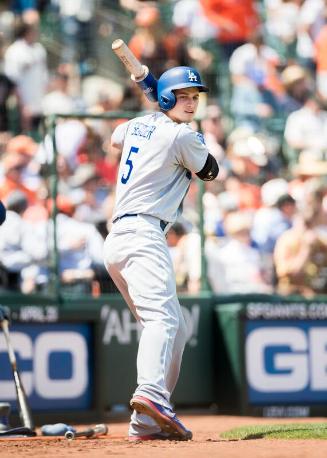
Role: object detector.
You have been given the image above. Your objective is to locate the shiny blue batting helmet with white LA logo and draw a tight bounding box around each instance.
[157,67,208,111]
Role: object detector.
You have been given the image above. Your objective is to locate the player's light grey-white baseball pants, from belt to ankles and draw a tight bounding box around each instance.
[104,215,186,434]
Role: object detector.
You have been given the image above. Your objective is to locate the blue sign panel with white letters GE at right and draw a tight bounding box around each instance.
[245,321,327,403]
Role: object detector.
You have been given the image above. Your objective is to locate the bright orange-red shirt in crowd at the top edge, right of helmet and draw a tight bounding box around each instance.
[200,0,260,43]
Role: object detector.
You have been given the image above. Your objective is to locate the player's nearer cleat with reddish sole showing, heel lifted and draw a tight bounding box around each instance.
[130,396,192,441]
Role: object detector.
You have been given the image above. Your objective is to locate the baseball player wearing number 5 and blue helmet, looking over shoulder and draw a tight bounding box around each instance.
[104,67,219,440]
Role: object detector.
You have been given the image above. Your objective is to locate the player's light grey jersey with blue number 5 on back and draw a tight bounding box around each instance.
[111,112,209,223]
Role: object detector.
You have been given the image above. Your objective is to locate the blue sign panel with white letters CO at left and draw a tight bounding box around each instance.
[0,324,92,410]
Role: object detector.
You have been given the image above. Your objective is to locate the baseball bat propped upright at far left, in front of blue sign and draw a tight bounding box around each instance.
[1,319,34,430]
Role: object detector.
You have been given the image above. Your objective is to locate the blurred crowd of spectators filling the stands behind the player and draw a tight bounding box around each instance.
[0,0,327,297]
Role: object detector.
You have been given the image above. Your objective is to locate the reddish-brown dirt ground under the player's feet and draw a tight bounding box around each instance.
[0,415,327,458]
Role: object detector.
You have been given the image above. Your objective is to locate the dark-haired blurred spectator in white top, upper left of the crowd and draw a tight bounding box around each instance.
[4,24,48,132]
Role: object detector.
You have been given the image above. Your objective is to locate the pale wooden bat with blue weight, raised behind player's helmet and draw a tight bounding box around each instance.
[111,38,158,102]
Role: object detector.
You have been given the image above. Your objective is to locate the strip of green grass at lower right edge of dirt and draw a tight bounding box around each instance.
[220,422,327,440]
